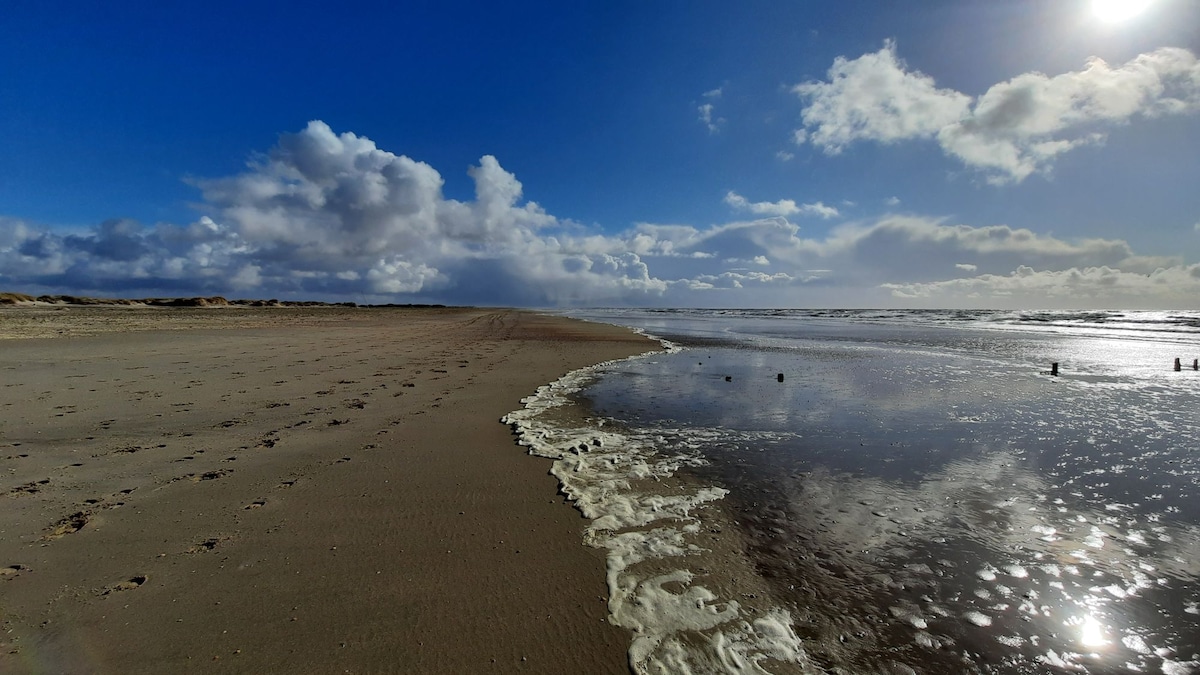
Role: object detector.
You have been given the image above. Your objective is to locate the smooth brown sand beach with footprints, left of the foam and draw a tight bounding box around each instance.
[0,307,656,674]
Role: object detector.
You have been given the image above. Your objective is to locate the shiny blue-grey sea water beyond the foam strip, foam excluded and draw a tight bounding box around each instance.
[568,307,1200,673]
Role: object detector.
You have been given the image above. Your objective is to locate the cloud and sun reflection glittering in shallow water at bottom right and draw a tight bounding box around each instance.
[756,453,1200,673]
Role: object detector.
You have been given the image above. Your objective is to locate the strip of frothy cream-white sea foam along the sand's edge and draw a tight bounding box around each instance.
[502,341,808,674]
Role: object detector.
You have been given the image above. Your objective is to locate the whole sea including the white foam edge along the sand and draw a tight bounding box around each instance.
[505,310,1200,675]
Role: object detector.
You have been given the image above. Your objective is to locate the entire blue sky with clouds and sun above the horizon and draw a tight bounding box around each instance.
[0,0,1200,309]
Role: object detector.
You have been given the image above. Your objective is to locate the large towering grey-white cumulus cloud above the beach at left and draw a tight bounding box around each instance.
[0,121,666,304]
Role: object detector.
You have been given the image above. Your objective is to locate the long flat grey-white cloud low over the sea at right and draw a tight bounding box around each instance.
[614,216,1182,305]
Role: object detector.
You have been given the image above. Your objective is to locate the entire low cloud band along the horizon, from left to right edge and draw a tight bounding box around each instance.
[0,121,1200,306]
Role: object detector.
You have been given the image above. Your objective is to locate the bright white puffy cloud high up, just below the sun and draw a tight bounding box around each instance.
[792,41,1200,184]
